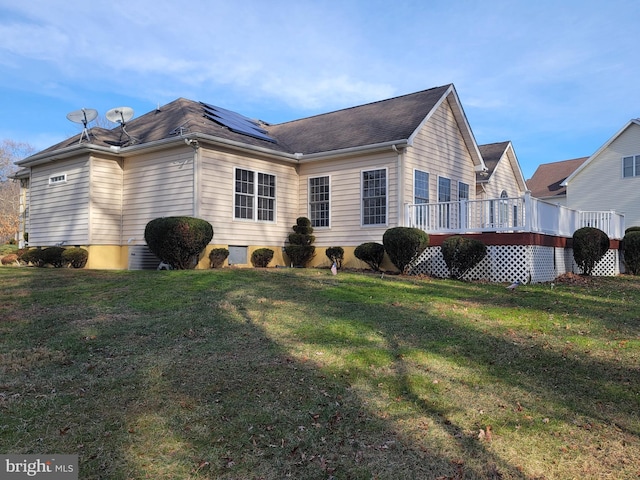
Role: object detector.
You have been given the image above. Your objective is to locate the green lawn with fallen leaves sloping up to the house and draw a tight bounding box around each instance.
[0,267,640,480]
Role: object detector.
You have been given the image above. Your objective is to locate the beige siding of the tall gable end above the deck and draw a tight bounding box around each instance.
[403,101,476,203]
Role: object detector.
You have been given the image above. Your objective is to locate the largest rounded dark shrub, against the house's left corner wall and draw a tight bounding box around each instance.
[144,217,213,270]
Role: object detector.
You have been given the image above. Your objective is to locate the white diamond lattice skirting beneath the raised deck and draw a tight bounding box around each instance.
[411,245,620,283]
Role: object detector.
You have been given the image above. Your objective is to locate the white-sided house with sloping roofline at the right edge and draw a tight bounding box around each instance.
[562,119,640,227]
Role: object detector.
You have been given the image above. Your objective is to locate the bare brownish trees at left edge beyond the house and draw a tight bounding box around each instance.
[0,140,35,243]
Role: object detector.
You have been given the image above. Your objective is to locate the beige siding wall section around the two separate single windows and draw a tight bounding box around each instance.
[300,149,398,247]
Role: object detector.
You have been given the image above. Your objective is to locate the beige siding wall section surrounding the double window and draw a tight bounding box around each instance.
[198,149,300,247]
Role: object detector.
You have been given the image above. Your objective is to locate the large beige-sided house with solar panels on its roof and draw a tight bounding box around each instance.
[17,85,484,268]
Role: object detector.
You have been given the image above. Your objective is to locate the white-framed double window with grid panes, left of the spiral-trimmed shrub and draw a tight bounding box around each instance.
[234,168,276,222]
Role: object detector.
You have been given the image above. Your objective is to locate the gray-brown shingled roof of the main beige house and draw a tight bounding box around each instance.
[27,85,451,160]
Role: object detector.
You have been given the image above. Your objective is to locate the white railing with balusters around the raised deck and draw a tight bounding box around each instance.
[405,192,625,239]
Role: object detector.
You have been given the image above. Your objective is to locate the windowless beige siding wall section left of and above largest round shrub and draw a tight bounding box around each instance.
[122,147,193,245]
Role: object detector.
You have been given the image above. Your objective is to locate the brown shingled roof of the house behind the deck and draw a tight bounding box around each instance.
[527,157,589,206]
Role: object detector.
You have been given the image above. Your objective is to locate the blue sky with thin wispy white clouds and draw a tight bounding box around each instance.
[0,0,640,179]
